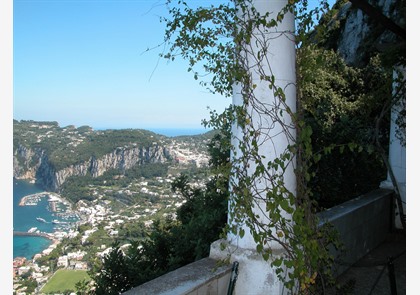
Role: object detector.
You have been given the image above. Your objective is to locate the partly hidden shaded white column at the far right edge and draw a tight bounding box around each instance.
[380,67,406,229]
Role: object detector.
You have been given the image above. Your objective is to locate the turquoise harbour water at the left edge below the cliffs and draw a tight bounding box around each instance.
[13,179,54,259]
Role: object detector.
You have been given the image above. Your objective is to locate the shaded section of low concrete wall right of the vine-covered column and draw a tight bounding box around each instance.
[318,189,393,276]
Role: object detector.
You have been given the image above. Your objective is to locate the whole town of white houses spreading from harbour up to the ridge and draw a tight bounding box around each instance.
[13,125,213,295]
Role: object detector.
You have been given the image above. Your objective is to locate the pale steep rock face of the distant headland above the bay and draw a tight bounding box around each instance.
[13,145,169,191]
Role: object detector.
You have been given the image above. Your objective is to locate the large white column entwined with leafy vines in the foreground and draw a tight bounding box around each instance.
[210,0,296,295]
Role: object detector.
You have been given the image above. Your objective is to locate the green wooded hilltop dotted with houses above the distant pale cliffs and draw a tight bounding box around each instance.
[13,120,165,171]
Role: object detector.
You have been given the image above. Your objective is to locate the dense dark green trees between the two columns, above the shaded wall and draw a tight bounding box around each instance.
[298,46,391,209]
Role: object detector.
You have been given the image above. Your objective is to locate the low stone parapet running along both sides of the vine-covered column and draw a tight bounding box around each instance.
[123,189,393,295]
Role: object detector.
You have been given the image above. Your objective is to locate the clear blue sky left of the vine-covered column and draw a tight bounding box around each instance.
[13,0,230,129]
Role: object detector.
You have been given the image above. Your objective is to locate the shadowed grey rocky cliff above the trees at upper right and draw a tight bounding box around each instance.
[321,0,406,66]
